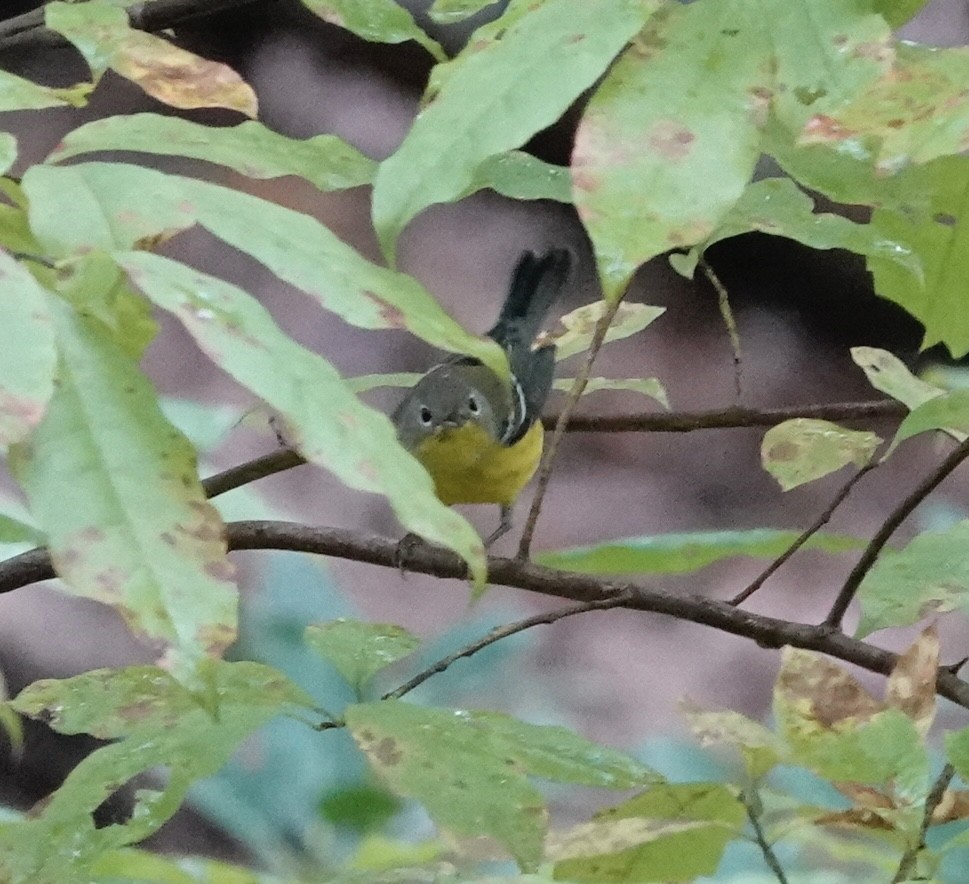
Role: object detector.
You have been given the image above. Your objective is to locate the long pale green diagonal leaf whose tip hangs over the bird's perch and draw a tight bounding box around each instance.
[115,252,485,581]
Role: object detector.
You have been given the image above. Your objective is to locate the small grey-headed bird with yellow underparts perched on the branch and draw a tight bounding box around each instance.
[392,249,572,547]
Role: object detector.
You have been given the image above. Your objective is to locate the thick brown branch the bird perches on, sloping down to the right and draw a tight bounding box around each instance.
[0,521,969,709]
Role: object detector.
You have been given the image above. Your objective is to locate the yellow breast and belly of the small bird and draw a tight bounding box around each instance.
[414,421,545,506]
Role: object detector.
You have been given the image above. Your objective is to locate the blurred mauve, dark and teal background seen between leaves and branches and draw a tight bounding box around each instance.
[0,0,969,865]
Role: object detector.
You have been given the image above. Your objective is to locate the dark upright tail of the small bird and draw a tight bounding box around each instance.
[488,249,572,353]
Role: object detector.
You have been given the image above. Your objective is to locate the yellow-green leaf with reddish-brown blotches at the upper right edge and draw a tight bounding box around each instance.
[801,42,969,174]
